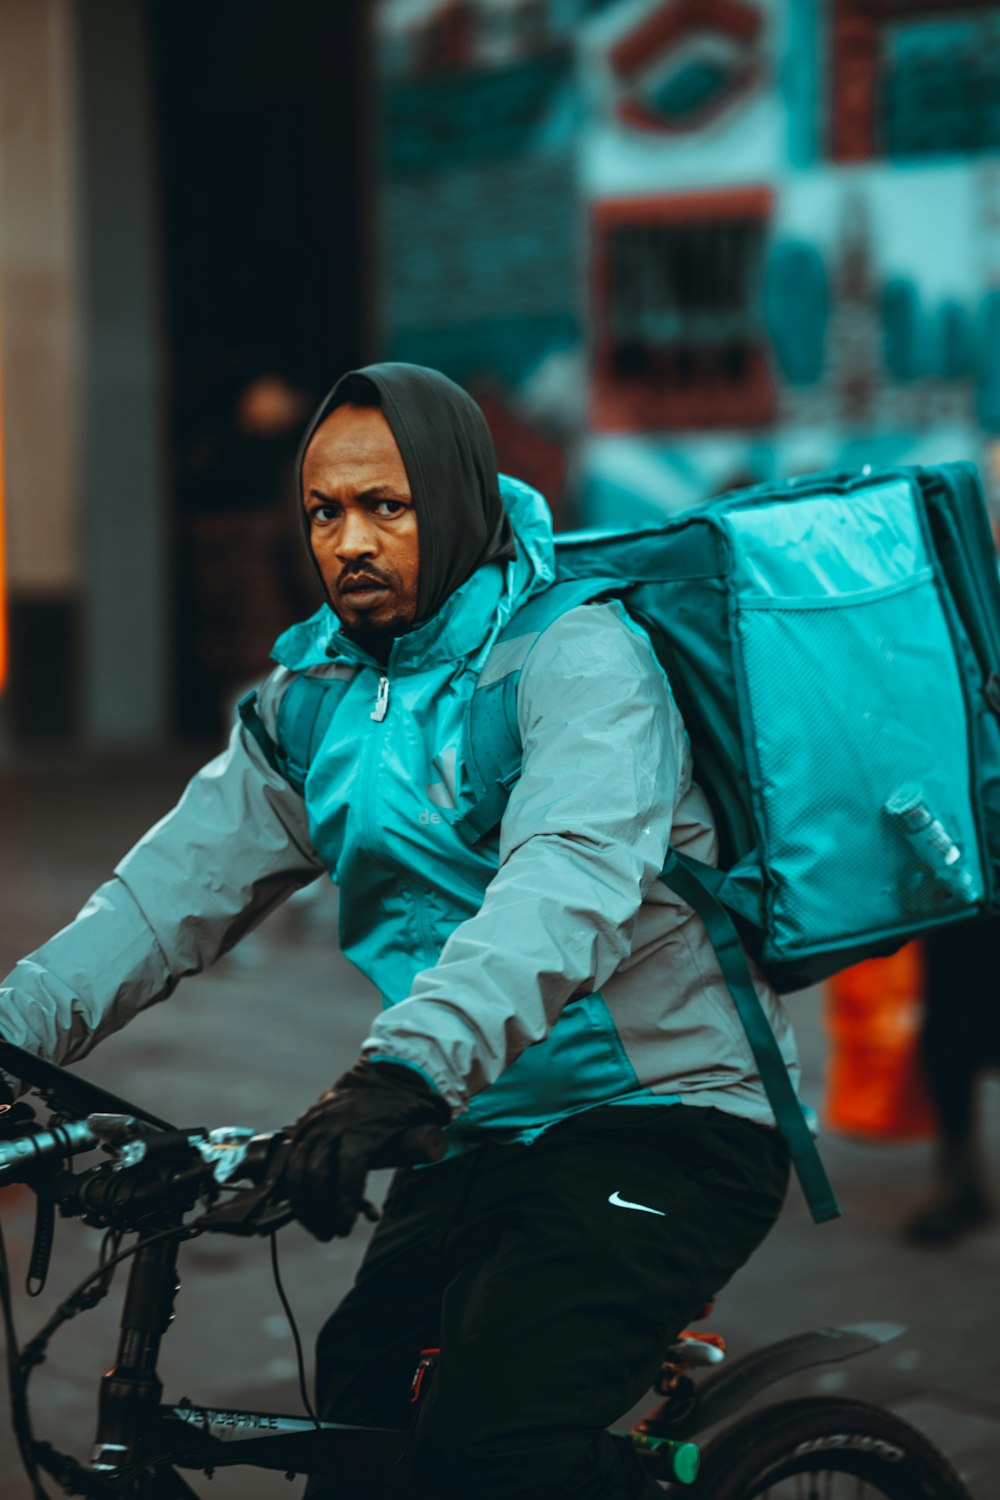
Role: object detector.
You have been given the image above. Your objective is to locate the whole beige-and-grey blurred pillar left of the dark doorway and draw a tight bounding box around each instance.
[0,0,166,747]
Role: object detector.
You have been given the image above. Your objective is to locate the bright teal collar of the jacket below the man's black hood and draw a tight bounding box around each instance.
[271,474,556,674]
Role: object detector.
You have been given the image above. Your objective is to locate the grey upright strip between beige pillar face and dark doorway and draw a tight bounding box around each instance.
[75,0,169,747]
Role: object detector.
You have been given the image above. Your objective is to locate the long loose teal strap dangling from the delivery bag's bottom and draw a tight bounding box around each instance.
[660,849,841,1224]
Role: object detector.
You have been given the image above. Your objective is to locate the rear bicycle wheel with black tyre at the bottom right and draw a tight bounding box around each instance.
[688,1397,972,1500]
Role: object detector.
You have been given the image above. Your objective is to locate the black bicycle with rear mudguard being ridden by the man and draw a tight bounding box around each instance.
[0,1043,970,1500]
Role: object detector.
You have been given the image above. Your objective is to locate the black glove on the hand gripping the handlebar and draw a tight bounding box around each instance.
[285,1062,451,1239]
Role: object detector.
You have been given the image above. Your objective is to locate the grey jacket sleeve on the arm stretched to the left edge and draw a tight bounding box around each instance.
[0,674,322,1086]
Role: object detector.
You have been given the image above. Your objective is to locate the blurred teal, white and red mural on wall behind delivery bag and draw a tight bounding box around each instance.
[376,0,1000,524]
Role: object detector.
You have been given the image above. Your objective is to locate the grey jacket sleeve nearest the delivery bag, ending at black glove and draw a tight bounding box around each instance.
[363,605,690,1112]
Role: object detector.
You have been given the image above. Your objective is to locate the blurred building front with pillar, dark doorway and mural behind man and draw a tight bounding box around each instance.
[0,0,1000,753]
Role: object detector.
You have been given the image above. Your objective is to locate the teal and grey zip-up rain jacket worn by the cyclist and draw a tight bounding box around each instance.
[0,480,796,1146]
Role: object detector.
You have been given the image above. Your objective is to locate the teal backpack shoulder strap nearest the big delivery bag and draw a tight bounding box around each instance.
[454,578,624,845]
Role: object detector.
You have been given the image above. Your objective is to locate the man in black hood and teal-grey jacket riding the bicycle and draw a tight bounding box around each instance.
[0,365,795,1500]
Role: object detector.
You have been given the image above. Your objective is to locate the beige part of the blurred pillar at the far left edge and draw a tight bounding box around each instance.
[0,0,81,741]
